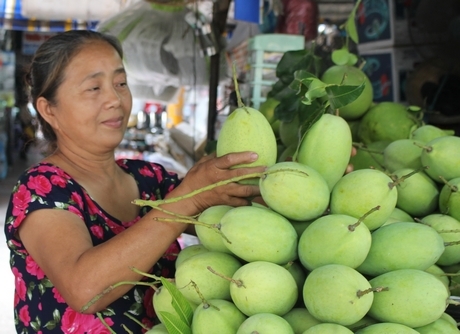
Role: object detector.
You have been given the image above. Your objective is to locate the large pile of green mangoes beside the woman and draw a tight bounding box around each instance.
[148,66,460,334]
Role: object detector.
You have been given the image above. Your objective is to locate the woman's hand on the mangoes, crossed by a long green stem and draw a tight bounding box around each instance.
[171,152,266,212]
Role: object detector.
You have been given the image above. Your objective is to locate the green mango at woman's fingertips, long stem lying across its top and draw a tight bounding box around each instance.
[259,161,330,221]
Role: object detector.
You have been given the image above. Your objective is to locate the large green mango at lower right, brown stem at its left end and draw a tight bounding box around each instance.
[363,270,449,333]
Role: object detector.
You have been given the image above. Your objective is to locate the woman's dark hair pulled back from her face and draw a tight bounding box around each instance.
[26,30,123,151]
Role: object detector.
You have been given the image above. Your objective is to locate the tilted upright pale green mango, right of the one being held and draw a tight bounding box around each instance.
[297,114,352,191]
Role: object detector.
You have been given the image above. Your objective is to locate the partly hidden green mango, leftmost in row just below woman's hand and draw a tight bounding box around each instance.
[195,205,233,253]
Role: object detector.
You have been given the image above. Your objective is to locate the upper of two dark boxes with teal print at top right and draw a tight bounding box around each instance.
[356,0,416,50]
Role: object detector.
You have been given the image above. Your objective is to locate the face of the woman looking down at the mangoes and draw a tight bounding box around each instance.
[47,41,132,154]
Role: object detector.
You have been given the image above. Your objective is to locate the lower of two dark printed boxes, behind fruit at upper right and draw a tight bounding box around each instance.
[360,47,423,103]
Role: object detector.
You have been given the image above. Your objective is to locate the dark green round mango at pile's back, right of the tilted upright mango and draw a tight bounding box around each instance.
[358,102,418,144]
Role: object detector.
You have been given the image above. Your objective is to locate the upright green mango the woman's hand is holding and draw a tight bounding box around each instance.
[216,107,277,167]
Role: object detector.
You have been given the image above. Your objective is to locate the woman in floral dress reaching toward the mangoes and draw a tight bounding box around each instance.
[5,31,264,334]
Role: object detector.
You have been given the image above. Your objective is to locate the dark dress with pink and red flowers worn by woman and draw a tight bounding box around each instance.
[5,160,180,334]
